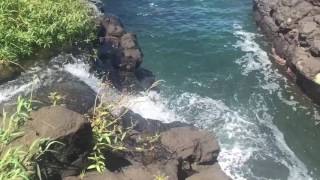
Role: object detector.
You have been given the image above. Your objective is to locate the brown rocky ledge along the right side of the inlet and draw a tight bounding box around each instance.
[254,0,320,104]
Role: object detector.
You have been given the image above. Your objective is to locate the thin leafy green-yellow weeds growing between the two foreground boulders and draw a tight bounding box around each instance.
[84,101,161,174]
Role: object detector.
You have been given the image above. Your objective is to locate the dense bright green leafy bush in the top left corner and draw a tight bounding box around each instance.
[0,0,95,64]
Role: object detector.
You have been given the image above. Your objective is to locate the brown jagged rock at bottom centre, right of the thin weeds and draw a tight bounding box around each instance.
[64,119,230,180]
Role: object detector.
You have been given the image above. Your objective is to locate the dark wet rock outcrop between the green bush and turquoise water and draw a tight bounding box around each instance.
[93,15,155,91]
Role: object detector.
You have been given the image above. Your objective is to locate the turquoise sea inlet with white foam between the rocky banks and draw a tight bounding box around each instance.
[106,0,320,180]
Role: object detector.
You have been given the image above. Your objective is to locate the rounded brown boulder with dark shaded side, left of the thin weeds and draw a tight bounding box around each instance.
[14,106,92,179]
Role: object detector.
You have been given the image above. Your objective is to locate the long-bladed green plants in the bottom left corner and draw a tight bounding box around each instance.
[0,95,58,180]
